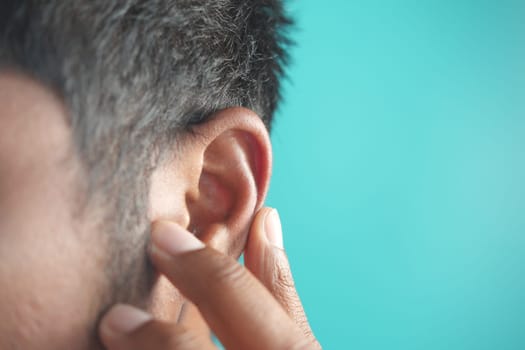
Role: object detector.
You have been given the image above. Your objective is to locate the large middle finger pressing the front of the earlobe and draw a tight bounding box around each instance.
[150,222,310,349]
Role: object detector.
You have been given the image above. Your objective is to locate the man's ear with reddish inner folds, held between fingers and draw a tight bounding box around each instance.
[149,107,272,257]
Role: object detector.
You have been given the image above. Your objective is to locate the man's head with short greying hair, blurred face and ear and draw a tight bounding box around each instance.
[0,0,289,349]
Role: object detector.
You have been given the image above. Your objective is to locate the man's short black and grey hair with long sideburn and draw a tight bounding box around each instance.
[0,0,291,308]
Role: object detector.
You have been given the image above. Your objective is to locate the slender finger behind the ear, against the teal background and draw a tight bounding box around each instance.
[244,208,315,340]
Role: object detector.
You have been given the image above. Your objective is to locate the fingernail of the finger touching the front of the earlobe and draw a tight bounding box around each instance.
[150,221,204,256]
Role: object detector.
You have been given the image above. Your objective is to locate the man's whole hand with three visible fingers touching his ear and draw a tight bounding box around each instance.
[99,208,321,350]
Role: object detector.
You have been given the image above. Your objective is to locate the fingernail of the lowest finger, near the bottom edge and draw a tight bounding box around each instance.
[100,304,152,336]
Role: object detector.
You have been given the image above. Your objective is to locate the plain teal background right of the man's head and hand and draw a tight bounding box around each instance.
[268,0,525,350]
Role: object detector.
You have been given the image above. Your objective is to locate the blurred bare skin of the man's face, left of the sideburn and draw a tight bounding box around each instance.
[0,75,106,349]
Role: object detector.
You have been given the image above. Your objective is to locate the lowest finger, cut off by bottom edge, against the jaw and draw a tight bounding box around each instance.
[99,304,216,350]
